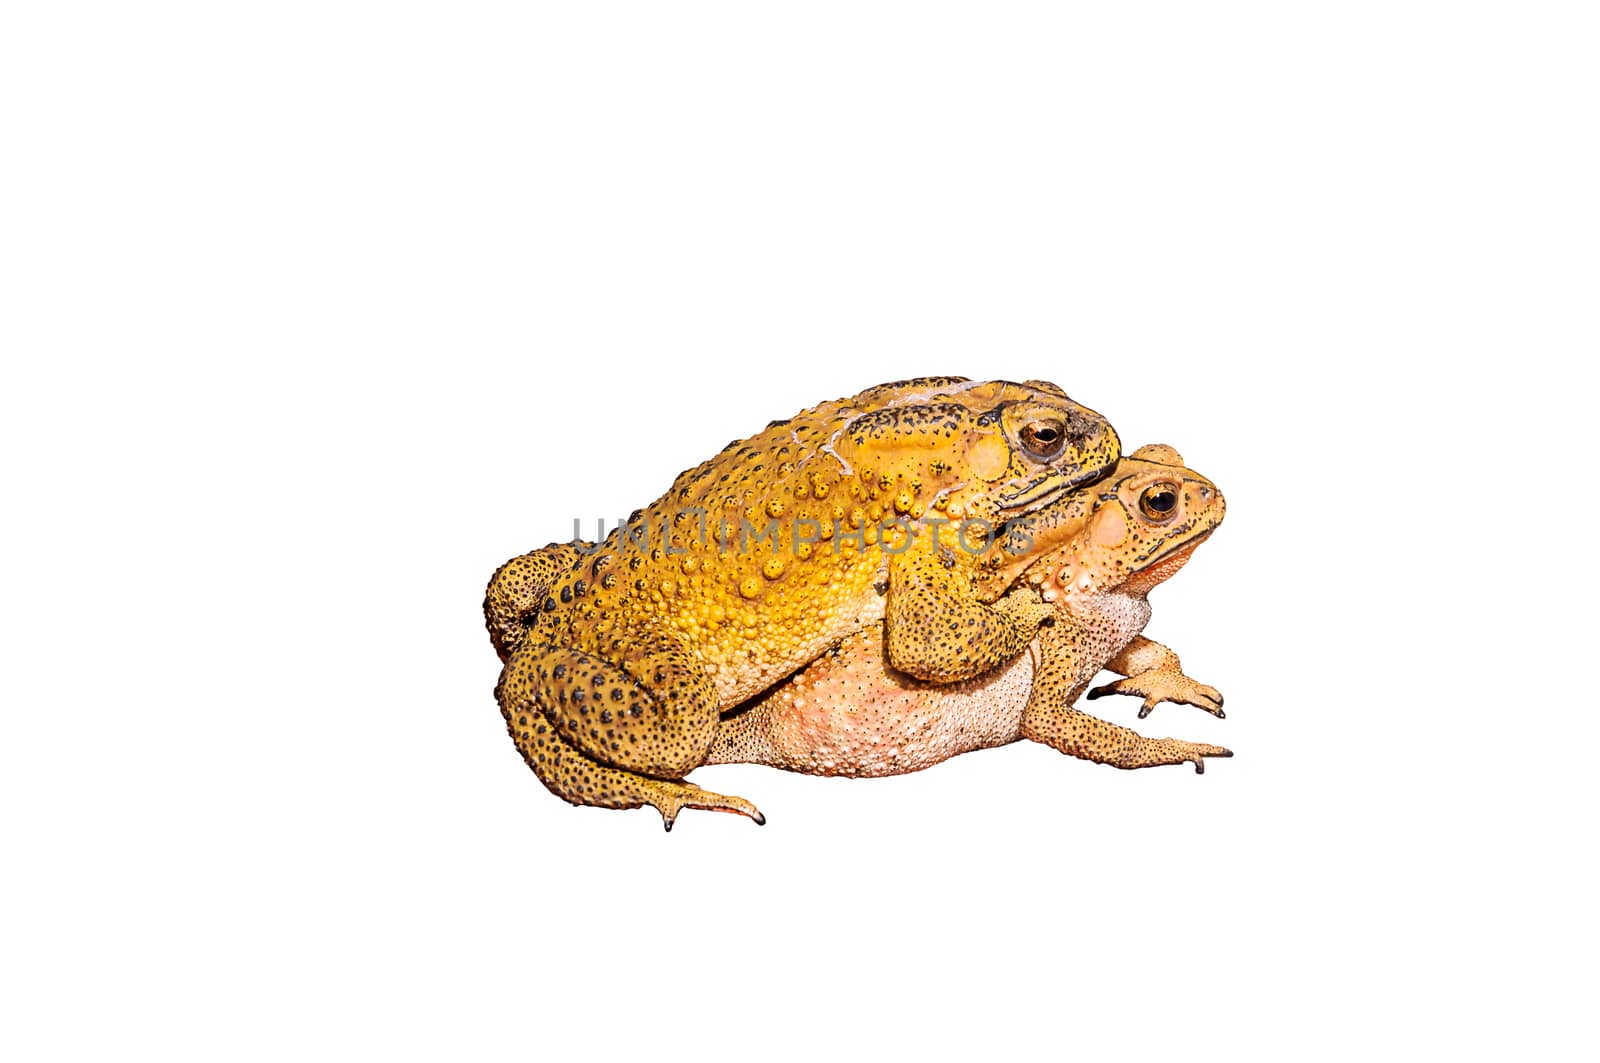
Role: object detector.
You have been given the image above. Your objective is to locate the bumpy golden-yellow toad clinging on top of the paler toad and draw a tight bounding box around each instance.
[485,376,1120,829]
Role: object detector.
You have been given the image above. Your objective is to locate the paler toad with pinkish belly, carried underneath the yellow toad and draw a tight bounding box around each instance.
[706,445,1232,776]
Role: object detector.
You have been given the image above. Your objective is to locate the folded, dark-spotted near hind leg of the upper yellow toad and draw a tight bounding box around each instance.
[494,645,766,831]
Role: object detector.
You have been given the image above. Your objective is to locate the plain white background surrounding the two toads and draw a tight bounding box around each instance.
[0,2,1600,1060]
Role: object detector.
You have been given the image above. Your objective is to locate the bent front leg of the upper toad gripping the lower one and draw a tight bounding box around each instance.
[885,543,1054,684]
